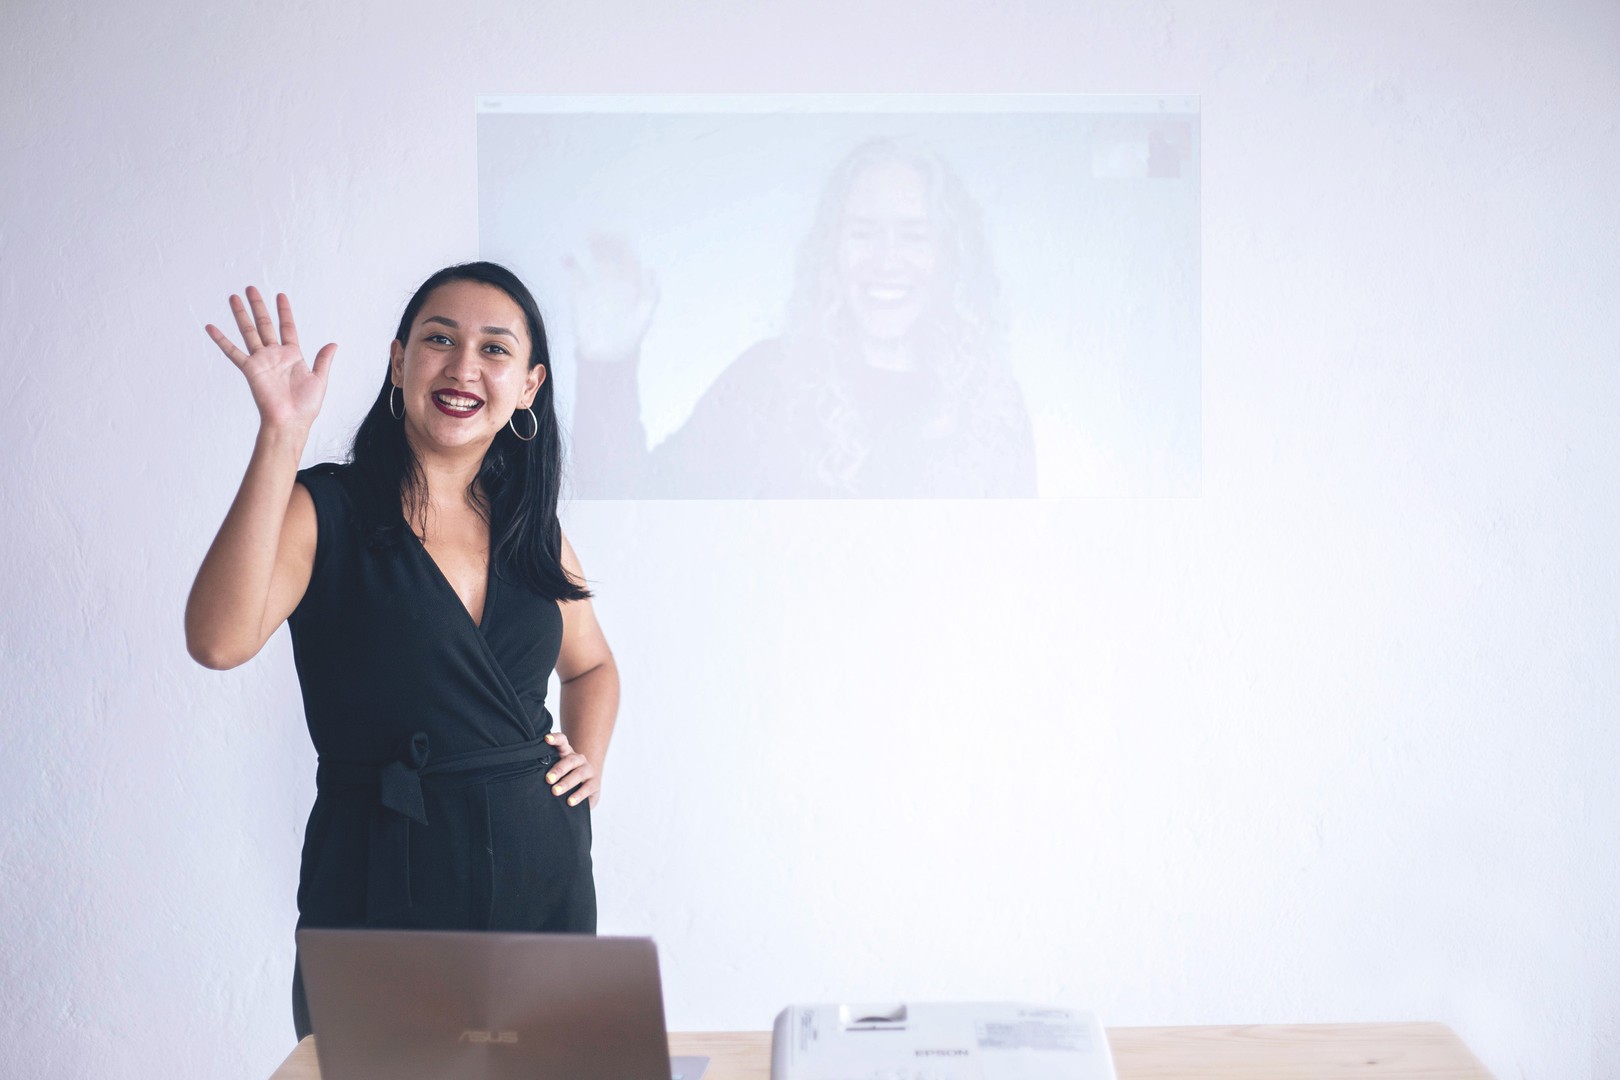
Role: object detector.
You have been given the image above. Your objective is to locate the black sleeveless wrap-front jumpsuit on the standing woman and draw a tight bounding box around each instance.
[287,465,596,1038]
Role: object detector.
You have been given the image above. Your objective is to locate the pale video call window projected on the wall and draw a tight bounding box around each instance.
[478,96,1202,499]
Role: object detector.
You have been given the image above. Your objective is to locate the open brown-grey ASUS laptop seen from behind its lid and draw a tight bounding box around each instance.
[298,929,708,1080]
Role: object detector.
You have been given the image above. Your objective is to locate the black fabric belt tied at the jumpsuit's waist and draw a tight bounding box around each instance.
[314,732,557,921]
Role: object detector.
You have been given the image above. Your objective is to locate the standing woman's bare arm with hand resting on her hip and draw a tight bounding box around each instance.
[546,536,619,806]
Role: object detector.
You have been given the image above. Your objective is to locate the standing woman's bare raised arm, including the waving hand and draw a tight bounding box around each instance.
[186,287,337,669]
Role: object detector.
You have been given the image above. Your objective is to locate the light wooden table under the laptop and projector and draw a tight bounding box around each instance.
[271,1023,1490,1080]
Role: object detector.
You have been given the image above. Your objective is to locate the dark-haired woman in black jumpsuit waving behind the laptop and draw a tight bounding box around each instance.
[186,262,619,1038]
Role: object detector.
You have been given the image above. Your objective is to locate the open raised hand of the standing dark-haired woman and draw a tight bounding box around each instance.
[203,285,337,431]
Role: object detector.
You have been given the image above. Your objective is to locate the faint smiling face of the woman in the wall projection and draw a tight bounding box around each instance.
[838,162,940,343]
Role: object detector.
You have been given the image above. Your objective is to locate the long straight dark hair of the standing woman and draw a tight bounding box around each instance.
[348,262,590,601]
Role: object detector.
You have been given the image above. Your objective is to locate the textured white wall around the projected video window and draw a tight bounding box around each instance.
[0,0,1620,1080]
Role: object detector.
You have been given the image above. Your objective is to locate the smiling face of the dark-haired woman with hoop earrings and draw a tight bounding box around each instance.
[389,282,546,457]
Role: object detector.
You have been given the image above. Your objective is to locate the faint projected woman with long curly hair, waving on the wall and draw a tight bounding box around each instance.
[567,139,1035,499]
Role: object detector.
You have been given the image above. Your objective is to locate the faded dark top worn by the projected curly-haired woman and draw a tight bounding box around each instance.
[573,338,1035,499]
